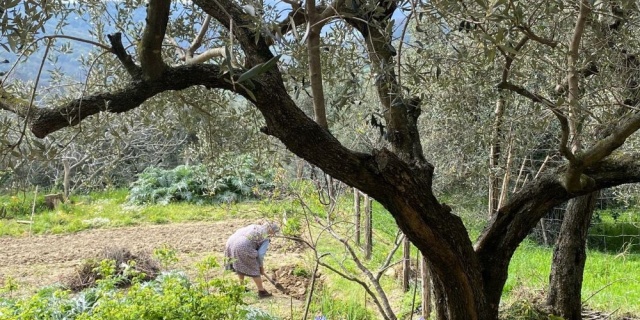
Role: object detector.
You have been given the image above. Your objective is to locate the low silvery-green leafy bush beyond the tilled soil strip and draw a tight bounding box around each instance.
[129,156,273,205]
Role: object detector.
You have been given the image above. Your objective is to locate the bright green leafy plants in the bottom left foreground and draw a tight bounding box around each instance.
[0,257,274,320]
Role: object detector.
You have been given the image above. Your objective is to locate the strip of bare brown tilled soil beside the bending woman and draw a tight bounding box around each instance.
[0,220,308,300]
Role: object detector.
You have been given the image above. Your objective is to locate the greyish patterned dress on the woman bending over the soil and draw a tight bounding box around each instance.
[224,224,269,277]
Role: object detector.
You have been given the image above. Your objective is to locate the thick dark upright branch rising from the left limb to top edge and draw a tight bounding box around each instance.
[138,0,171,80]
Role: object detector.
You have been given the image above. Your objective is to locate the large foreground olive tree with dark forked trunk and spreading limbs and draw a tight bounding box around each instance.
[0,0,640,319]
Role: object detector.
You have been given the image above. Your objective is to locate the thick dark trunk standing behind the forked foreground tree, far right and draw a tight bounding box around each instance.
[547,192,598,320]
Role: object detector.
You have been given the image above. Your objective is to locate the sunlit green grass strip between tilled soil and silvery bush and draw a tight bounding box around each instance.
[0,189,291,237]
